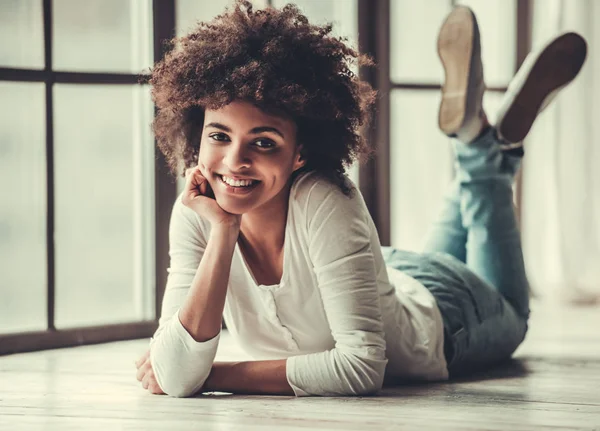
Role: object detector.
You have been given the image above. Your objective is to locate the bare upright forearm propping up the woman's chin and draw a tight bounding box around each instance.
[179,226,239,342]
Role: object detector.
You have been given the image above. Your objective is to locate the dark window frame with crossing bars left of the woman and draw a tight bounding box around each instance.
[0,0,176,355]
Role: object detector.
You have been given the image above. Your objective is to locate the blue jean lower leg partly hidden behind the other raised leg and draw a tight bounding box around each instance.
[423,180,467,262]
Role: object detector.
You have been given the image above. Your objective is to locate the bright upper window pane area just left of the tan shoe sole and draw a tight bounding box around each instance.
[390,0,451,84]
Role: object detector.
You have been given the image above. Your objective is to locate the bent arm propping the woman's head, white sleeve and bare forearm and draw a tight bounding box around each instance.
[150,199,238,397]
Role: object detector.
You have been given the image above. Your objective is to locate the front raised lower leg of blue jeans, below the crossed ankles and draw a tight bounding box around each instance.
[454,128,529,318]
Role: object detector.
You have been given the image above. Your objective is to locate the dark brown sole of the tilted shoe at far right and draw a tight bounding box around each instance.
[498,33,587,142]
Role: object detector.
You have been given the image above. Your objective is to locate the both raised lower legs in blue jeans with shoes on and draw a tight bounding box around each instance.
[432,6,587,316]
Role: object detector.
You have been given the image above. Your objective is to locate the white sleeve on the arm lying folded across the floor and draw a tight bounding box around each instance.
[286,180,387,396]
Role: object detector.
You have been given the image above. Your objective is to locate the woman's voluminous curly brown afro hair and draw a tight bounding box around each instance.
[150,0,376,194]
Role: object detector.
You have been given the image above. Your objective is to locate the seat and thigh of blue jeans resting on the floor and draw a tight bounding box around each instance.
[386,248,527,377]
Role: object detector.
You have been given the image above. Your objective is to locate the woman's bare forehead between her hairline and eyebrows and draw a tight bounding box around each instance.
[204,101,296,132]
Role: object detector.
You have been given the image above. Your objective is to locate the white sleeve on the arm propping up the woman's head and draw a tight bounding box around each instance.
[150,196,221,397]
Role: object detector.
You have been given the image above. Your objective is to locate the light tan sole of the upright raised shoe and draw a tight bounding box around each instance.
[437,7,474,136]
